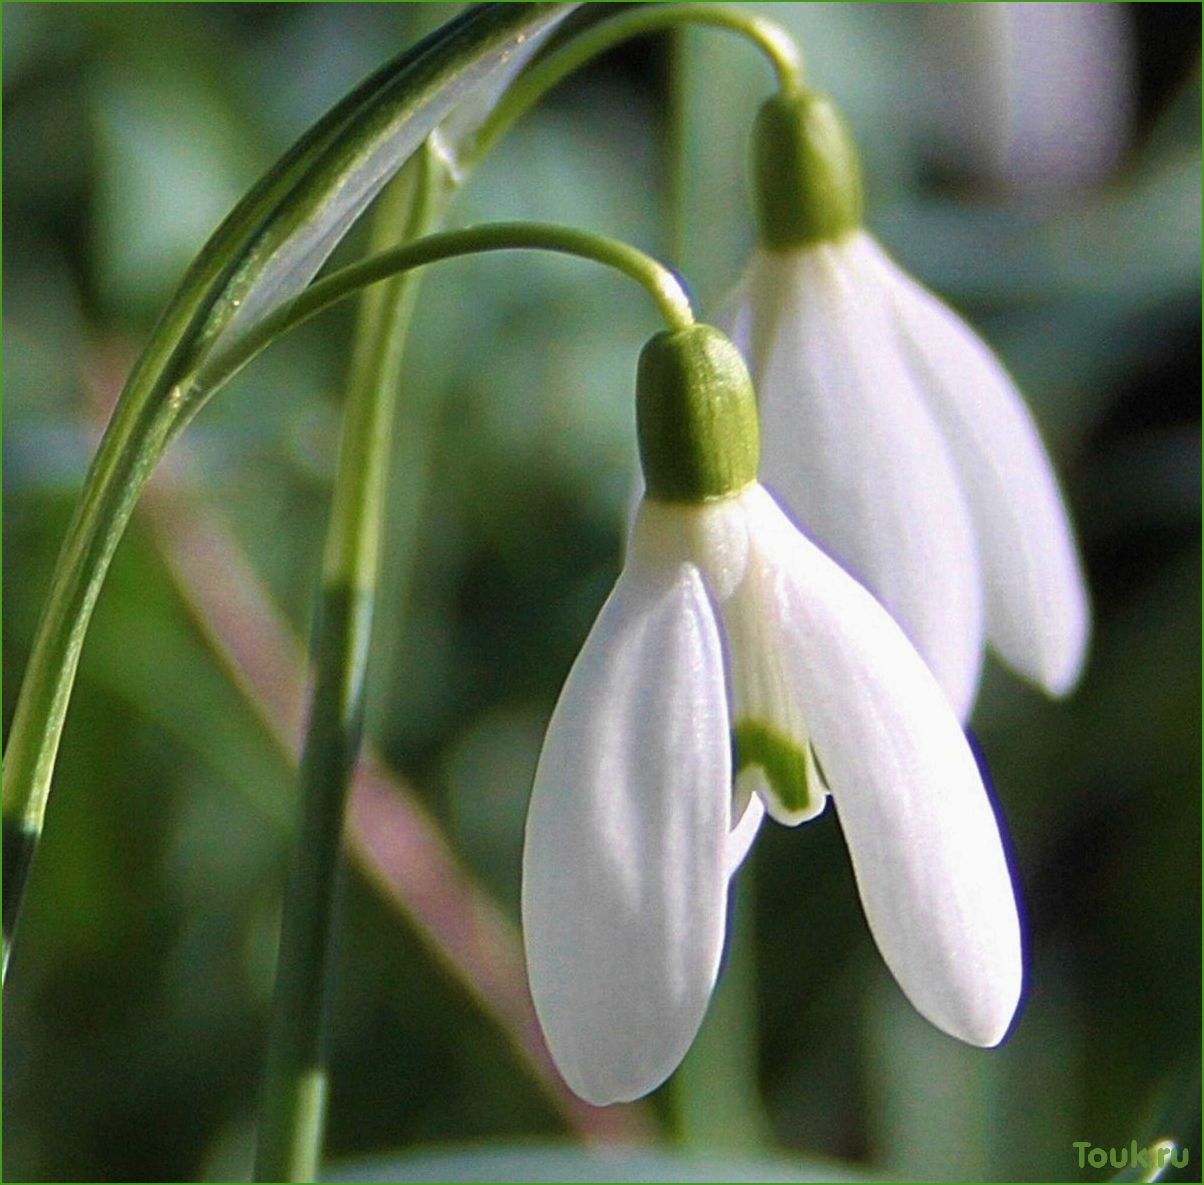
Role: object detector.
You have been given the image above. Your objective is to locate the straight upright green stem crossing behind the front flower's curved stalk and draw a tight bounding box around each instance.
[255,148,445,1181]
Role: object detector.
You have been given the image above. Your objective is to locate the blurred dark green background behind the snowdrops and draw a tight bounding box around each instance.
[2,2,1204,1180]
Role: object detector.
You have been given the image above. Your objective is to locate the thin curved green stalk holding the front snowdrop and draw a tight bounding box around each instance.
[175,223,694,416]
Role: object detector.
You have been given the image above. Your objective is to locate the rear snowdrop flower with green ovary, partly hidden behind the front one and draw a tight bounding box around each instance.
[720,92,1090,719]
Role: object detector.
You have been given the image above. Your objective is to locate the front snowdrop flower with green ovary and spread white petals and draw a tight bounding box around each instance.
[523,325,1021,1104]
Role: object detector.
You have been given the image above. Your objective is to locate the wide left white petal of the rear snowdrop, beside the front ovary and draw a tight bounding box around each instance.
[727,245,984,718]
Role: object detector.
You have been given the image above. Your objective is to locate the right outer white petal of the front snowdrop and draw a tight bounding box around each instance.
[750,491,1022,1045]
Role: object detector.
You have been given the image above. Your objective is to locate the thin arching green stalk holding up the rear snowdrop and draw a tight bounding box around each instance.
[468,2,803,167]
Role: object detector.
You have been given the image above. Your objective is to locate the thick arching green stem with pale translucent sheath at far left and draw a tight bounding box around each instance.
[2,4,574,974]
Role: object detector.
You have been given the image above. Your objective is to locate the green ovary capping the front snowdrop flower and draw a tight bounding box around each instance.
[636,325,761,503]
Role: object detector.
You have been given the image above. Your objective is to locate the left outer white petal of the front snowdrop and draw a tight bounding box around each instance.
[523,541,731,1106]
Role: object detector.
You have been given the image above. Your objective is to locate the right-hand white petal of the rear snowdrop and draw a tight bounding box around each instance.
[867,244,1091,695]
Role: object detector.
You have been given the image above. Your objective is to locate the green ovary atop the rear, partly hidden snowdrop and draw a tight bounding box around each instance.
[753,90,861,250]
